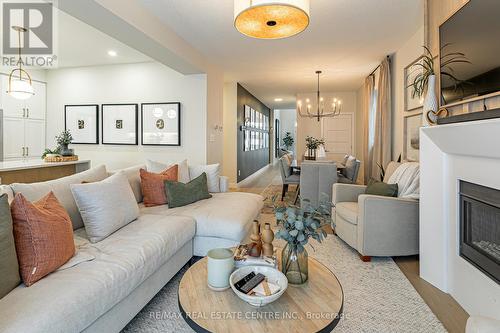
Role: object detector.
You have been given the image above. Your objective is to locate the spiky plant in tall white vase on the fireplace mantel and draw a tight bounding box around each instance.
[408,44,471,126]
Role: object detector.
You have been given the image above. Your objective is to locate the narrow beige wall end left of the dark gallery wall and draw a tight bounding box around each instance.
[222,82,238,184]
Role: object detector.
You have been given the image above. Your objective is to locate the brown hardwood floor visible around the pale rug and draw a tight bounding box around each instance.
[237,165,469,333]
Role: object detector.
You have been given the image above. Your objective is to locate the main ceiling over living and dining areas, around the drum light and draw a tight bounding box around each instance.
[140,0,423,109]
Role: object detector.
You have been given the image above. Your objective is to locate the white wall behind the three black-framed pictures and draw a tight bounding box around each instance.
[46,63,207,170]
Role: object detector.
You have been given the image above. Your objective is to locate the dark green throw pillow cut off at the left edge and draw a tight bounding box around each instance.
[0,193,21,298]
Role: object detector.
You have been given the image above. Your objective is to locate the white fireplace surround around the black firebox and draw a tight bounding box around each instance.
[420,119,500,319]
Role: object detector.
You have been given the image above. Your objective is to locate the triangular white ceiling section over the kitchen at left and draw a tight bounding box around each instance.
[56,10,152,68]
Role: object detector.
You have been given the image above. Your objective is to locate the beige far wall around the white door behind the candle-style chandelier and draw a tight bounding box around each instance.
[297,91,363,158]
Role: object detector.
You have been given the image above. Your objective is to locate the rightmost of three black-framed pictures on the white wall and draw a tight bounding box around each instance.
[141,102,182,147]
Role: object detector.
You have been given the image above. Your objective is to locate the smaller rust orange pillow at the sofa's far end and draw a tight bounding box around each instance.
[139,164,179,207]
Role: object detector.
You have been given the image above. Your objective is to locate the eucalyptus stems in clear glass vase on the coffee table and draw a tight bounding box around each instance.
[272,196,331,285]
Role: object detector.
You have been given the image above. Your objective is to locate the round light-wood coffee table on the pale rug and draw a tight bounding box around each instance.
[179,252,344,333]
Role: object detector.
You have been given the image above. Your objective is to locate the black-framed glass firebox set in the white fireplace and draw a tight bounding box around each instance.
[459,180,500,284]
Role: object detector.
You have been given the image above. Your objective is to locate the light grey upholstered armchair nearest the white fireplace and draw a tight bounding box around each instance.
[332,162,419,261]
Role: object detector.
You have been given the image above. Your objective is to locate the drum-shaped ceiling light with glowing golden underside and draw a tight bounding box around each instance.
[234,0,309,39]
